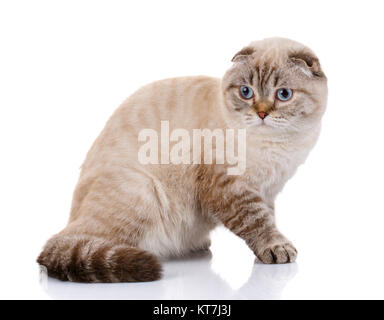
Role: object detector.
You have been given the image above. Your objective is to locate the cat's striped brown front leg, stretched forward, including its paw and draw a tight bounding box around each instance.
[200,169,297,263]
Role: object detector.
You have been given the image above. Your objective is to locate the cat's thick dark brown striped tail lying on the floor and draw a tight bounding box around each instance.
[37,234,162,282]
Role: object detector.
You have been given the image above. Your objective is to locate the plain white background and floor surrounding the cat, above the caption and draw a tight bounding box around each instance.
[0,0,384,299]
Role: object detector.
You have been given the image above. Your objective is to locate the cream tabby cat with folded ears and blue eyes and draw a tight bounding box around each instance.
[37,38,327,282]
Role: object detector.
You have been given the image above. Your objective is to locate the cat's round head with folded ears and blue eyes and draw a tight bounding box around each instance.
[223,38,327,132]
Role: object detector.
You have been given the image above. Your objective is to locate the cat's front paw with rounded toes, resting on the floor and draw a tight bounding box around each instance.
[256,241,297,264]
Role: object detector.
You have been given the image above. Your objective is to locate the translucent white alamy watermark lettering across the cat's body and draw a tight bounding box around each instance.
[138,121,246,175]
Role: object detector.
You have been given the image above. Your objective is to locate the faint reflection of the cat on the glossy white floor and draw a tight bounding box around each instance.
[41,251,297,300]
